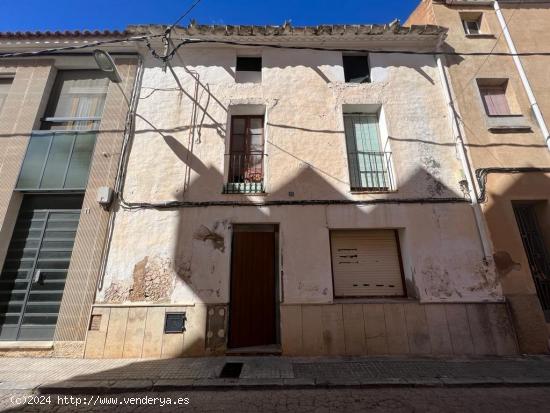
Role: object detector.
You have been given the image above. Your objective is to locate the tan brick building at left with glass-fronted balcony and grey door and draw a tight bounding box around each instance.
[0,31,138,356]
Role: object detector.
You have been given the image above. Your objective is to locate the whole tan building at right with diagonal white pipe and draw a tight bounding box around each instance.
[407,0,550,353]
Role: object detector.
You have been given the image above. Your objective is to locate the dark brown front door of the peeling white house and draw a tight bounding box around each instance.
[228,225,277,348]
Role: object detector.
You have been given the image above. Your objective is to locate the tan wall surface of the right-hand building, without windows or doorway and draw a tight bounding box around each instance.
[409,0,550,353]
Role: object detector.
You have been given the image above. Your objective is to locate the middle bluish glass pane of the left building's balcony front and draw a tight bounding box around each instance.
[40,133,74,189]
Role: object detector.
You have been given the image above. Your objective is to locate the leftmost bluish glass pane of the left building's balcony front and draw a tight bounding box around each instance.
[17,135,52,189]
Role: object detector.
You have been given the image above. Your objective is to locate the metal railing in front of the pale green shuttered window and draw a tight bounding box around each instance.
[348,151,394,191]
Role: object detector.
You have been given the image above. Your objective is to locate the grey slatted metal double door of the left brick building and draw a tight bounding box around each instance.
[0,195,82,341]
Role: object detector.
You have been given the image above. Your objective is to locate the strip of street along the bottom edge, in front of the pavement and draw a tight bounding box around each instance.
[0,387,550,413]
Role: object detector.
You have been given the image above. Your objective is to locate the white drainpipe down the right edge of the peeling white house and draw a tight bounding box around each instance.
[436,54,493,263]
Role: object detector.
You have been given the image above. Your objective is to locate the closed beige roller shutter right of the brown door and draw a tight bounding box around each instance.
[331,230,405,297]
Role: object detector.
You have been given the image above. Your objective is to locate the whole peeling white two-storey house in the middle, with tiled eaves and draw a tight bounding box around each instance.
[85,24,518,358]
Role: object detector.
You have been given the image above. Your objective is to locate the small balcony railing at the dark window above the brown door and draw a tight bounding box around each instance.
[223,153,266,194]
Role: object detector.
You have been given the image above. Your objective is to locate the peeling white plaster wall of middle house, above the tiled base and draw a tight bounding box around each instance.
[97,41,508,354]
